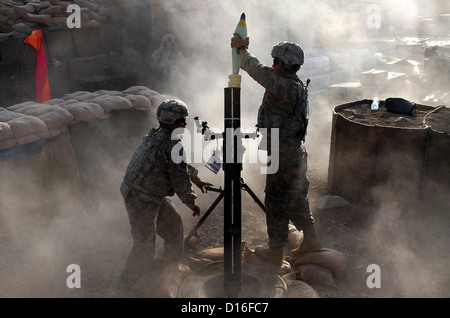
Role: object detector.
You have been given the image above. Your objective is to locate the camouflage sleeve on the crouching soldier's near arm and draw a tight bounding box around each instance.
[165,140,197,208]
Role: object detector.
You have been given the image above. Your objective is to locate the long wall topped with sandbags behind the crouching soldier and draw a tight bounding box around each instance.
[0,86,172,232]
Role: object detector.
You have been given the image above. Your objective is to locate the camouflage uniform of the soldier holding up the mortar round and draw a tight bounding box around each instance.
[241,53,314,248]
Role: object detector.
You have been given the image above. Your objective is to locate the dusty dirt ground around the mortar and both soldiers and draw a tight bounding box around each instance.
[0,144,450,298]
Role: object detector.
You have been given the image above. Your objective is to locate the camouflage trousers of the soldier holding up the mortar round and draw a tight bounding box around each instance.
[265,145,314,247]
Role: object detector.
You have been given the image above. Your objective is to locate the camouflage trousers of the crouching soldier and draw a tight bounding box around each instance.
[121,191,184,287]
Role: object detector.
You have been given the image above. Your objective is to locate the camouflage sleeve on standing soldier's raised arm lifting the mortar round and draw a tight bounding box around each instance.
[241,52,277,94]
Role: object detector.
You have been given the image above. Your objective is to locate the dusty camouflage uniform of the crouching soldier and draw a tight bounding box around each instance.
[120,127,201,287]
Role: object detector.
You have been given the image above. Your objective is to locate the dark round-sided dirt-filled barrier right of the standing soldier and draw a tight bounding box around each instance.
[328,100,450,209]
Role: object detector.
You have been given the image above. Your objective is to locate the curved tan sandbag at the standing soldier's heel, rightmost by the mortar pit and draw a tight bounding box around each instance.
[294,248,347,278]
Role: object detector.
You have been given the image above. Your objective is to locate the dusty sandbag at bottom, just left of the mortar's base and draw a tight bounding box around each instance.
[144,263,192,298]
